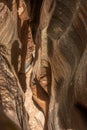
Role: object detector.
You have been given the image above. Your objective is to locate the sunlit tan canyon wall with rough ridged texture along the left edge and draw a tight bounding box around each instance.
[0,1,29,130]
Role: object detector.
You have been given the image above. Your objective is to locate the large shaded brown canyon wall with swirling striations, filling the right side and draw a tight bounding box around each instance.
[33,0,87,130]
